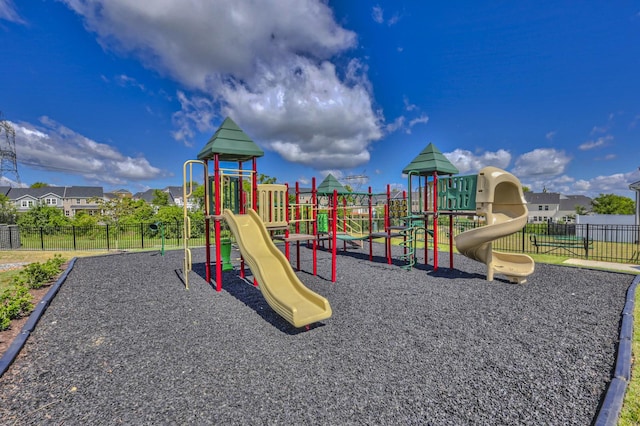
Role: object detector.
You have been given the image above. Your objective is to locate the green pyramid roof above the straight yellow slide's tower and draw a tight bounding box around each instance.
[198,117,264,161]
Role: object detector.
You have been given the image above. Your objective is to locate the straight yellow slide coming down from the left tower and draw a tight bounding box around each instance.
[224,209,331,327]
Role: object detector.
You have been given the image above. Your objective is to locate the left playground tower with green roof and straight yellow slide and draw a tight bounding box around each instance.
[183,118,332,327]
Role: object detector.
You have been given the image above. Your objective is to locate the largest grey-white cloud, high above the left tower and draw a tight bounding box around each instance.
[63,0,383,170]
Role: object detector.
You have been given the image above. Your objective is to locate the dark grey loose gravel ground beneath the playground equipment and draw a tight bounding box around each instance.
[0,246,633,425]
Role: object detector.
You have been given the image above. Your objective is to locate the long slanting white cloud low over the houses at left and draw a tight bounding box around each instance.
[11,117,163,184]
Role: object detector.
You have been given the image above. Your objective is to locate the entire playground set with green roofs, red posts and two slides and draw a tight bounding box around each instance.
[183,118,535,327]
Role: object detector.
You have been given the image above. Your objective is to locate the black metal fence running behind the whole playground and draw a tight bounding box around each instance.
[0,218,640,263]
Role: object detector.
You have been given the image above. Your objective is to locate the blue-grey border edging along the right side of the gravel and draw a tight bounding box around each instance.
[594,275,640,426]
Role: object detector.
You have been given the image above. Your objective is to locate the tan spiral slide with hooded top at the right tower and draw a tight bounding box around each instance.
[455,167,535,284]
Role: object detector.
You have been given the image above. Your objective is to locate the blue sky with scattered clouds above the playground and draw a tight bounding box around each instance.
[0,0,640,197]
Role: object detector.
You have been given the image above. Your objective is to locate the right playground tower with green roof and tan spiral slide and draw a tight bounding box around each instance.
[403,144,535,283]
